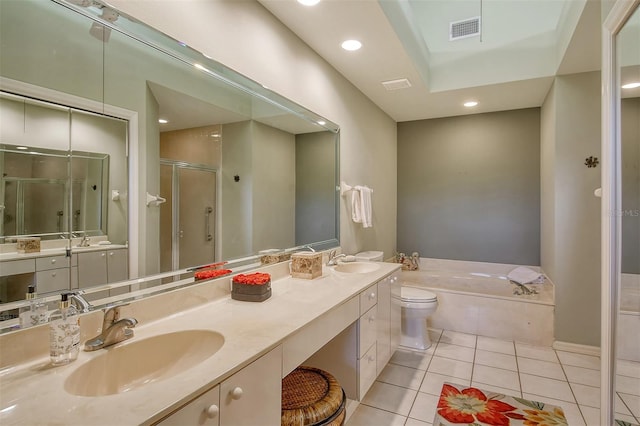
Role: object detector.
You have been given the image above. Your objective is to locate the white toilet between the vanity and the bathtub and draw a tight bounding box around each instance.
[394,286,438,350]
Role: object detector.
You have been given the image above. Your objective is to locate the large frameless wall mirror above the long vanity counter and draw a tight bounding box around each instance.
[0,0,339,328]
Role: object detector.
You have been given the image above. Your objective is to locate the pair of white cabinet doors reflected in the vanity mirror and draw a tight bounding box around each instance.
[78,248,128,288]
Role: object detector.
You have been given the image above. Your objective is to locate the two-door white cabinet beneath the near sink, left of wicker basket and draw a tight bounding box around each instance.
[156,346,282,426]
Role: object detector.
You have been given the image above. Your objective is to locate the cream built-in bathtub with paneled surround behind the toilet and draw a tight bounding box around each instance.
[401,258,555,346]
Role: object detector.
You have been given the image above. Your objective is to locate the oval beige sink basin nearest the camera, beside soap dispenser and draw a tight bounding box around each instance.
[64,330,224,396]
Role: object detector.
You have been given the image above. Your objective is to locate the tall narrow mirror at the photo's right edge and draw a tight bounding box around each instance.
[615,2,640,420]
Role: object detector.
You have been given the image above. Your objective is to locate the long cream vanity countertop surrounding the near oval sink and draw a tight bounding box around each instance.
[0,263,400,425]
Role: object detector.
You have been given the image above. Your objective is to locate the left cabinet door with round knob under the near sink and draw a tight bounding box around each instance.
[156,386,220,426]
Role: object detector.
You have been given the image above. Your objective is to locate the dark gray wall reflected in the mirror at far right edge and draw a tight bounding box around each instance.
[620,98,640,274]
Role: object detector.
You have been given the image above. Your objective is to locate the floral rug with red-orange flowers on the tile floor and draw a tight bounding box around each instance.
[433,383,568,426]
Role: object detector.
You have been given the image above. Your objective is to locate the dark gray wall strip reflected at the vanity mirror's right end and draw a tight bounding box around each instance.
[296,132,336,245]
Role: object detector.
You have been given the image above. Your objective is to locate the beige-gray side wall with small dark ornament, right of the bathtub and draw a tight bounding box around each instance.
[541,72,601,346]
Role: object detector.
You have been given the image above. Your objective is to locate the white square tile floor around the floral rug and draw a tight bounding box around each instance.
[347,330,640,426]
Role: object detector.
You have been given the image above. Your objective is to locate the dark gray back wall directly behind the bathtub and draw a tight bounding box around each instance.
[397,108,540,265]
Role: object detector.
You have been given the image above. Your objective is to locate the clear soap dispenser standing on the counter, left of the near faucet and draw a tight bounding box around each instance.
[49,293,80,365]
